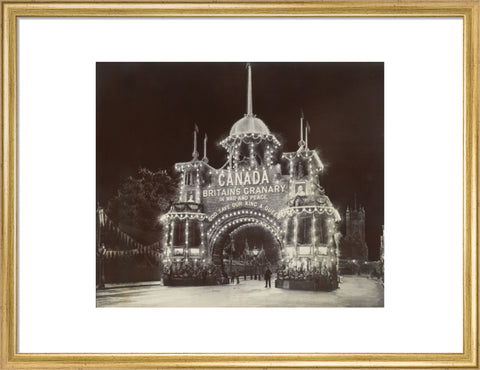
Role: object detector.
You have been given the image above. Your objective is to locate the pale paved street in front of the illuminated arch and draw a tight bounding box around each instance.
[97,276,383,307]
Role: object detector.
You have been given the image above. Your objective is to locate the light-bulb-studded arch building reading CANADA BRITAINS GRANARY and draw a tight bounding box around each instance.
[161,64,340,290]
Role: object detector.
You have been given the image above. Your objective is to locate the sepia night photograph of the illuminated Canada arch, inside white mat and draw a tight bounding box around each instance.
[92,61,388,307]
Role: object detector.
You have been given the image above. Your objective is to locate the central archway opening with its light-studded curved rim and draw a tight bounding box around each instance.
[208,208,282,278]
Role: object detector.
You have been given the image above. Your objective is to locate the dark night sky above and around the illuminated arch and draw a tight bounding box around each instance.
[96,63,384,259]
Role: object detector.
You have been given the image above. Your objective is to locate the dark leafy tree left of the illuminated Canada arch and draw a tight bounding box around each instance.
[106,168,178,244]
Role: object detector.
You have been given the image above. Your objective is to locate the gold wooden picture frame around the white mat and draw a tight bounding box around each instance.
[0,0,480,369]
